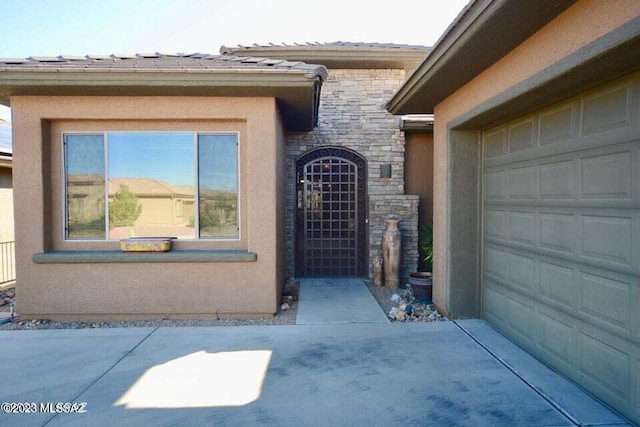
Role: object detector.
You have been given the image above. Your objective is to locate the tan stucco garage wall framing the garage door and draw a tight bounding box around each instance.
[433,0,640,316]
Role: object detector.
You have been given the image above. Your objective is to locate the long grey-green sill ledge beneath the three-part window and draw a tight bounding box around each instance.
[31,250,258,264]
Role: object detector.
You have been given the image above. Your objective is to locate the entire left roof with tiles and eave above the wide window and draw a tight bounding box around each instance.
[0,52,329,131]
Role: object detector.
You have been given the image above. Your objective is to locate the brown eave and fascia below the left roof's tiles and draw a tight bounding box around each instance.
[0,66,328,131]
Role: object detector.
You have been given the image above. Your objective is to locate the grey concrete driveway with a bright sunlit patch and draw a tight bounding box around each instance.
[0,320,626,426]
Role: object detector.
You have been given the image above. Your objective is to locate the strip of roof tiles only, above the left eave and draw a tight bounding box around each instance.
[0,52,326,78]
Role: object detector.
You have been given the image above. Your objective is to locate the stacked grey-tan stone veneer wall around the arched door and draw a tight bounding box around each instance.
[285,69,418,276]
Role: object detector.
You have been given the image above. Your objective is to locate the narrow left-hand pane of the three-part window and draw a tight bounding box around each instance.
[65,135,106,239]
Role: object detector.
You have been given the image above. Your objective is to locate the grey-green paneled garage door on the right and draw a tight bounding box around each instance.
[482,74,640,422]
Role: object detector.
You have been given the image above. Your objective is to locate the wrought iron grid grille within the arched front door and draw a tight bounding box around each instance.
[303,158,358,276]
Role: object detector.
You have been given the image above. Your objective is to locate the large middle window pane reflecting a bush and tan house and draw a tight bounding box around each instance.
[108,132,196,240]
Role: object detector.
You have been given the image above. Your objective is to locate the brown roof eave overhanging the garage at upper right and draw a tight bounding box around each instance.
[387,0,576,114]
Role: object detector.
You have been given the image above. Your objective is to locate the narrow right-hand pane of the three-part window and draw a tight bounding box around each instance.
[198,135,238,238]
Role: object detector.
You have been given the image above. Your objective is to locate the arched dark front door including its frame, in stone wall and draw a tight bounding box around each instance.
[296,147,368,277]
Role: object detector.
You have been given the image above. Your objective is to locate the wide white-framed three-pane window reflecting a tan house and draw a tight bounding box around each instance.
[63,131,240,241]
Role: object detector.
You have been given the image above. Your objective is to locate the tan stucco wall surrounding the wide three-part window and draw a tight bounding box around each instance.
[11,96,284,319]
